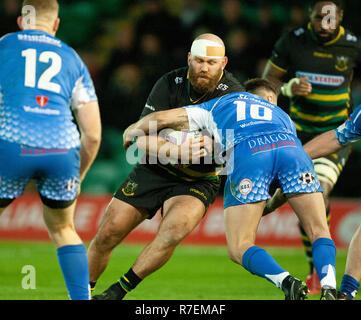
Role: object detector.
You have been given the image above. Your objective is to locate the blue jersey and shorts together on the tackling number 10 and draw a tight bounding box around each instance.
[186,92,322,208]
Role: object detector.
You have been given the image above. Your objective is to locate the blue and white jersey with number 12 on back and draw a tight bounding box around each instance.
[0,30,97,148]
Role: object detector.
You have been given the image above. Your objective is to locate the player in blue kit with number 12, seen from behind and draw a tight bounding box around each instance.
[0,0,101,300]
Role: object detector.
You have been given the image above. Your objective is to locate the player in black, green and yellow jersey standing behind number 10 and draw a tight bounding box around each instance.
[264,0,361,293]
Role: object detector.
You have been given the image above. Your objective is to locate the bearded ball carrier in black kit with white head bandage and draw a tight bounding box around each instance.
[88,34,243,300]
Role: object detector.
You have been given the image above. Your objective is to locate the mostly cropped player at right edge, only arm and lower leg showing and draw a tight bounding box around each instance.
[304,105,361,300]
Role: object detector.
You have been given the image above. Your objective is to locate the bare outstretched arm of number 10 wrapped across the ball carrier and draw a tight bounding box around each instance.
[123,108,189,149]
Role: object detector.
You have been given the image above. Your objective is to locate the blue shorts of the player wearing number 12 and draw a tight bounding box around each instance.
[0,139,80,207]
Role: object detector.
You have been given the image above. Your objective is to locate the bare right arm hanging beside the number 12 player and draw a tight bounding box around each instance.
[74,101,101,182]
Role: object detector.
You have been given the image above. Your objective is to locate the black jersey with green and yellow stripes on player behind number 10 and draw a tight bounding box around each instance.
[270,24,361,134]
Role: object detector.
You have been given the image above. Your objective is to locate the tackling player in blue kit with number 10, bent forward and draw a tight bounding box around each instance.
[124,79,336,300]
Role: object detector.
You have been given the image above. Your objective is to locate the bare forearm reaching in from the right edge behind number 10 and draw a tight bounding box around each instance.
[303,130,342,159]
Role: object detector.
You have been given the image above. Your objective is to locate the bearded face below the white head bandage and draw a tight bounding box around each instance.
[188,56,225,94]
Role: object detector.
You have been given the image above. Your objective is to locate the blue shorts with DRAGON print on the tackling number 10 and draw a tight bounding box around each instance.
[224,133,322,208]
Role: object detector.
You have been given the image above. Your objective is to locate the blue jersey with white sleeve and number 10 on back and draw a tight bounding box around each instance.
[185,92,296,152]
